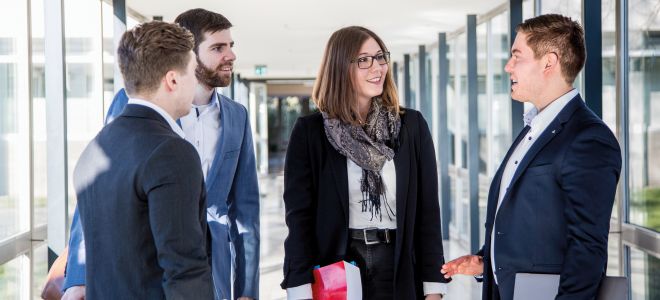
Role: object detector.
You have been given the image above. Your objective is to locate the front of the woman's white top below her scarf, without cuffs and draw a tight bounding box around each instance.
[346,158,396,229]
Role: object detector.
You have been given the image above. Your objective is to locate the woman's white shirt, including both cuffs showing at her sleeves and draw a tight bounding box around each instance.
[286,159,447,300]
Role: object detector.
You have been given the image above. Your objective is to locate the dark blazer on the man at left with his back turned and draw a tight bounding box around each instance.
[74,104,213,300]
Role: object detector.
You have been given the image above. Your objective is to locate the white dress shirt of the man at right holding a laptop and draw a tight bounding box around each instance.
[490,89,578,284]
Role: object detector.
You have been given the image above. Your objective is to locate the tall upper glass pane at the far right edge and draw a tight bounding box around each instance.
[628,0,660,231]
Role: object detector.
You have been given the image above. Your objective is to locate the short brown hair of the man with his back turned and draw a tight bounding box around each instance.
[117,21,193,94]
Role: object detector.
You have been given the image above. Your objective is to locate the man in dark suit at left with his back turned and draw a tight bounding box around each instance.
[73,21,213,299]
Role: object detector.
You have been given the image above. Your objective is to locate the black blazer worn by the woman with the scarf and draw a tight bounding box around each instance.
[281,109,447,299]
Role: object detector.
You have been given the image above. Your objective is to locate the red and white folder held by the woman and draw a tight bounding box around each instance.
[312,261,362,300]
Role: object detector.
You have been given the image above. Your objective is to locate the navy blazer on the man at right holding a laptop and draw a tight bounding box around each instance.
[482,95,621,300]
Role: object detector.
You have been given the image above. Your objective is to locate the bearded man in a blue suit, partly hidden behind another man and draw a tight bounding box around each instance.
[64,9,259,299]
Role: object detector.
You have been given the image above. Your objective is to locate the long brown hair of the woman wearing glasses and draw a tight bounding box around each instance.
[312,26,399,125]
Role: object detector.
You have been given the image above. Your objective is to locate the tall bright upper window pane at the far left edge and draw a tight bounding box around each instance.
[0,0,30,239]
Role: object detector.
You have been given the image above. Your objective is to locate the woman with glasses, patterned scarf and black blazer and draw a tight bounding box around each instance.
[282,26,447,299]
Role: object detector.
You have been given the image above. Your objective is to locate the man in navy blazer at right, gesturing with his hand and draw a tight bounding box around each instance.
[442,15,621,300]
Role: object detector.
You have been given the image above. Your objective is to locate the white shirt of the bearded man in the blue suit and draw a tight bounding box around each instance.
[179,91,222,178]
